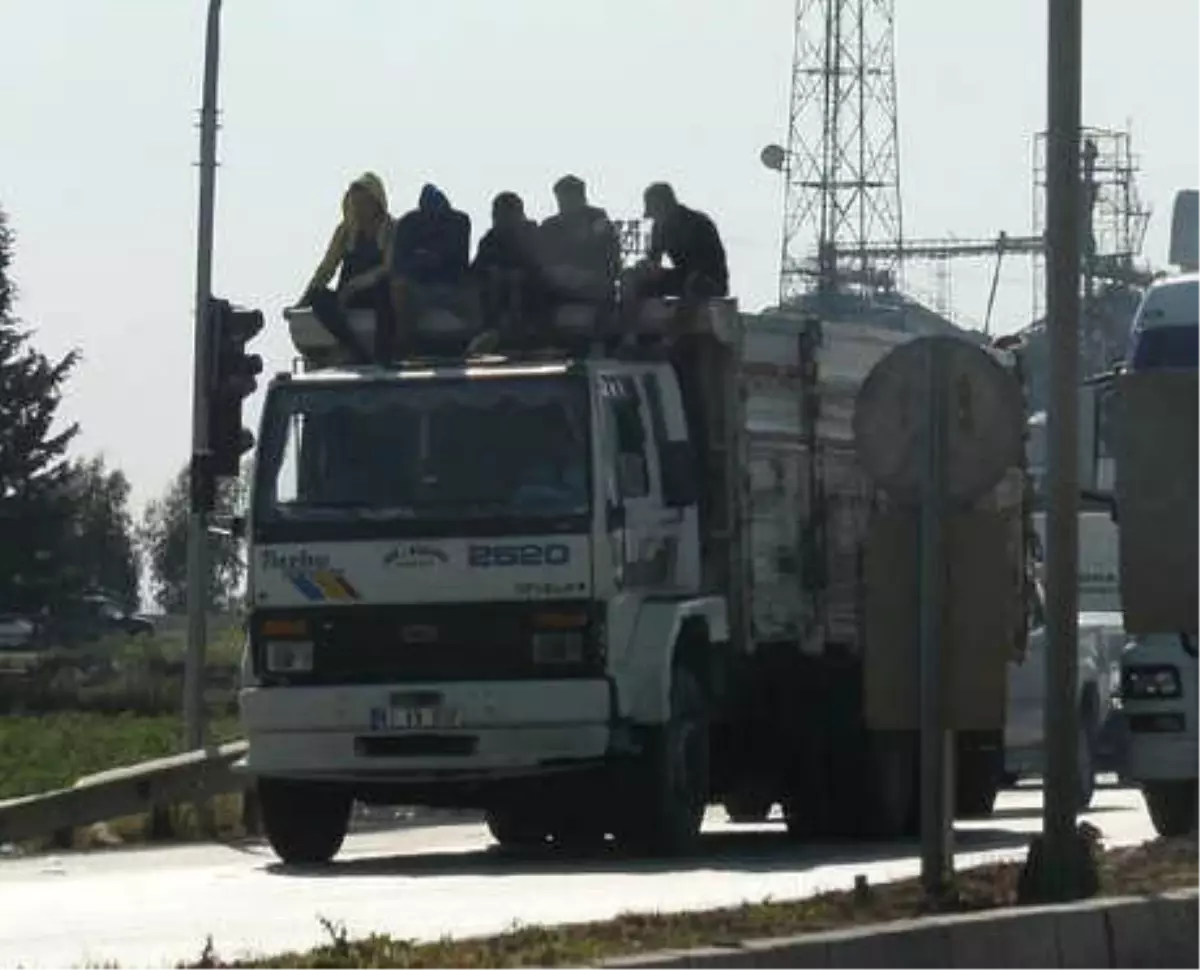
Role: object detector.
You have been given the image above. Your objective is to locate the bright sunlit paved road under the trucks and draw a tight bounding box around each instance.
[0,788,1154,970]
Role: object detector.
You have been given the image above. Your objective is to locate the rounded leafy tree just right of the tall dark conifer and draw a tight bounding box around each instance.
[67,456,142,610]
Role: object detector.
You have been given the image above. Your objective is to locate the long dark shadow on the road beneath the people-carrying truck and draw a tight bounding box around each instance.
[264,828,1030,879]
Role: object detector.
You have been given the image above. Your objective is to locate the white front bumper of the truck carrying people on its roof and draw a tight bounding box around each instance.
[236,679,614,784]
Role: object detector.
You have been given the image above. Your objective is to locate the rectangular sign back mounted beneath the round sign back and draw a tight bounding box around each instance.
[864,509,1021,731]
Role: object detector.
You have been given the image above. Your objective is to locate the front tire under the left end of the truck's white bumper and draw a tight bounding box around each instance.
[256,778,354,866]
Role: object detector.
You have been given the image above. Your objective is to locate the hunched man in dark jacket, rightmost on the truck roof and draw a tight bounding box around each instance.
[632,182,730,299]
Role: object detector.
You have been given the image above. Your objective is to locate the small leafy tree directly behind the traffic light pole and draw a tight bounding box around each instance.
[140,466,245,613]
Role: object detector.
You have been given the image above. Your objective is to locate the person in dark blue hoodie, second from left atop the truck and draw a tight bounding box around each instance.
[390,184,470,352]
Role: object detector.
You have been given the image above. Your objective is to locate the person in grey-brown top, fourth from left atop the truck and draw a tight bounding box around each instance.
[540,175,620,303]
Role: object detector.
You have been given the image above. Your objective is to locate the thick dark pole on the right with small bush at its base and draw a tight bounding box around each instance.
[1022,0,1096,902]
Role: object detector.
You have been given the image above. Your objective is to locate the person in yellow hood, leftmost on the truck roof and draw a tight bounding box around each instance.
[300,172,396,364]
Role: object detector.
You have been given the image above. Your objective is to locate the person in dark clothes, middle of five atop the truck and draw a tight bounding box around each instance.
[468,192,546,353]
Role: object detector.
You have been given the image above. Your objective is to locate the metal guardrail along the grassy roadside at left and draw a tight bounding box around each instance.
[0,741,251,844]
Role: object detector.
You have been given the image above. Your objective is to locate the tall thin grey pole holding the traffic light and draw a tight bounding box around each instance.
[184,0,221,749]
